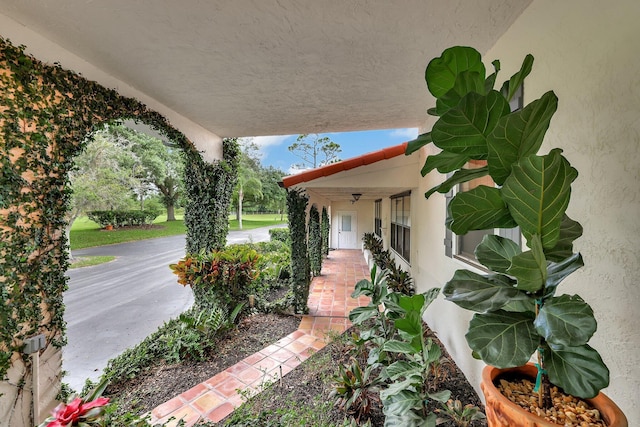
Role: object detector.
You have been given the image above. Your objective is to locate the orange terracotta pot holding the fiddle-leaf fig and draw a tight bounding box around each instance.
[480,364,629,427]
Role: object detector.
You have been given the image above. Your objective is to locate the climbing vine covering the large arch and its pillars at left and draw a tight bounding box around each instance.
[0,38,238,380]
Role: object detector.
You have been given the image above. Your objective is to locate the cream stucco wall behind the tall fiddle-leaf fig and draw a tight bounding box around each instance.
[413,0,640,425]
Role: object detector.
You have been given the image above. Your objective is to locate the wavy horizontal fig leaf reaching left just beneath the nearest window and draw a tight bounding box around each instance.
[442,270,527,313]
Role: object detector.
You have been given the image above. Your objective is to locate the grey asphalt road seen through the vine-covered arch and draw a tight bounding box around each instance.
[62,226,284,391]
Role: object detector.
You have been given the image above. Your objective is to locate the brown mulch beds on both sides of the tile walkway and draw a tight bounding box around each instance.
[105,314,486,427]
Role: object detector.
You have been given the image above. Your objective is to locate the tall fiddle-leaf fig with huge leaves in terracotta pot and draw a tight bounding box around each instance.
[407,46,627,426]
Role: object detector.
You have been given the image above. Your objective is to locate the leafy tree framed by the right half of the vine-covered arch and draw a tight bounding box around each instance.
[109,126,184,221]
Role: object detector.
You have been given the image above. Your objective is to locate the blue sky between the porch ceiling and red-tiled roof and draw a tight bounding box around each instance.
[246,128,418,174]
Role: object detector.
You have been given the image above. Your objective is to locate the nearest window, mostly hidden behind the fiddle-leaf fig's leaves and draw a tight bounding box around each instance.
[444,86,524,263]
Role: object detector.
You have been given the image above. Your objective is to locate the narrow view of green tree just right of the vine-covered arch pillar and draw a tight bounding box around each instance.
[234,138,263,230]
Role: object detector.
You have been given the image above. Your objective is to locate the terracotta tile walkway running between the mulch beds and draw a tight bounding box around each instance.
[151,250,369,427]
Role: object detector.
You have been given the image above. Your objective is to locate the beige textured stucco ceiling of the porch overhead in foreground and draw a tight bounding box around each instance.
[0,0,530,137]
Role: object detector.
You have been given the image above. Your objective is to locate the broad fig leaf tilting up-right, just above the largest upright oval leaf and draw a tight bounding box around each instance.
[487,92,558,185]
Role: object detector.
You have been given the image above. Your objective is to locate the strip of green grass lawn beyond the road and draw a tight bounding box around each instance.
[70,211,287,250]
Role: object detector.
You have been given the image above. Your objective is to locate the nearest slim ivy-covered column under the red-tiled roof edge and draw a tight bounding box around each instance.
[287,189,311,313]
